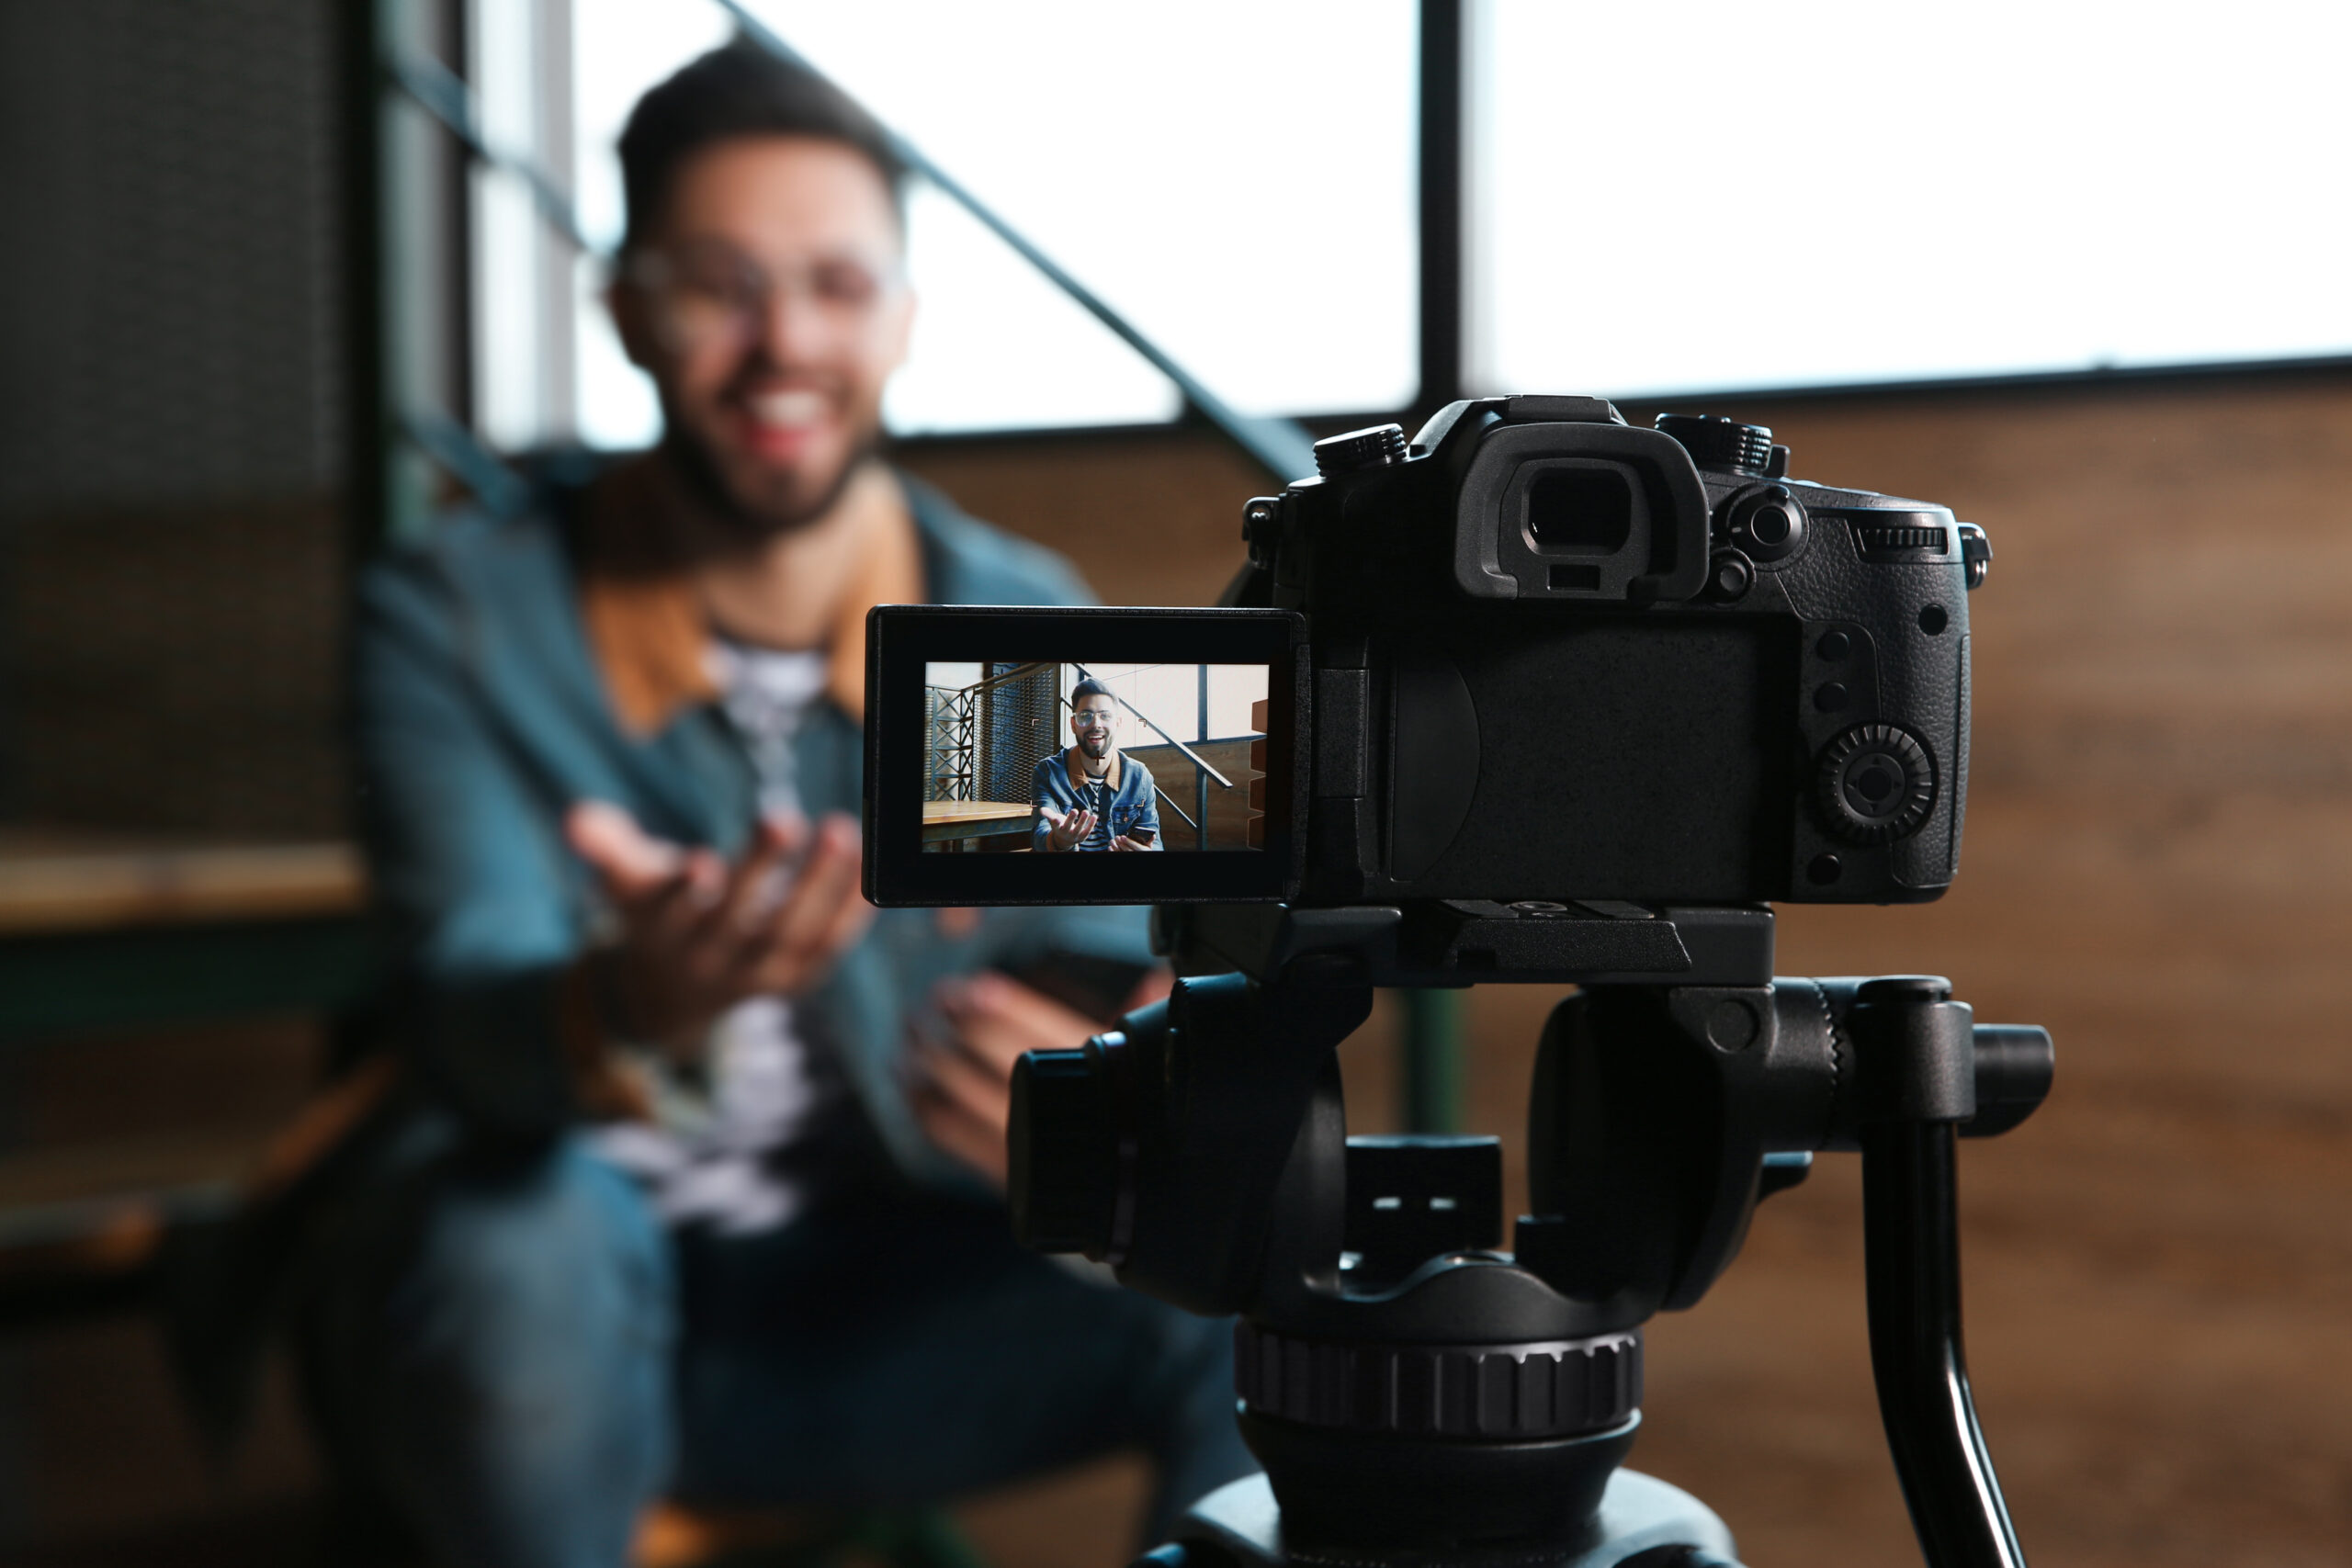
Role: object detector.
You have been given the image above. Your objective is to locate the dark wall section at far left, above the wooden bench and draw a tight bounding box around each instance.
[0,0,344,837]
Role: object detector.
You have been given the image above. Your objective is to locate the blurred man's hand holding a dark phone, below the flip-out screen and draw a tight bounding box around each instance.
[910,968,1169,1187]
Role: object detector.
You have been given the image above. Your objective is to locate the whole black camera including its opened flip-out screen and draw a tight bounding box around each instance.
[868,398,1990,917]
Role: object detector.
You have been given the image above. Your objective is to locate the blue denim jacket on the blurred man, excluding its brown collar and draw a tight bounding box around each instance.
[353,479,1150,1178]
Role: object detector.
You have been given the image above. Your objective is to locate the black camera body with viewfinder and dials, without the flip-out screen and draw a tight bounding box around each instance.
[1227,398,1990,905]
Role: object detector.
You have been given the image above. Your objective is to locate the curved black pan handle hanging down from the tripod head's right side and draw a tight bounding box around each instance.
[1860,1122,2025,1568]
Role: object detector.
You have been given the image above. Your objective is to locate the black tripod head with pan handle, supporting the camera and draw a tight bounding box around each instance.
[1012,903,2053,1568]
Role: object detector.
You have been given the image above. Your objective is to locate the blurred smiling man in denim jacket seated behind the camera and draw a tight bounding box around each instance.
[326,42,1249,1568]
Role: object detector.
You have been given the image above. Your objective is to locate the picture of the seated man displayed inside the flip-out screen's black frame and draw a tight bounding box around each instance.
[922,660,1270,856]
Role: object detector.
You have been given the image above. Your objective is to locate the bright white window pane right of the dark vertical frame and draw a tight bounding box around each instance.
[1467,0,2352,395]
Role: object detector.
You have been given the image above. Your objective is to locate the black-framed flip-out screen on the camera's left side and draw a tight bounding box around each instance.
[865,606,1301,905]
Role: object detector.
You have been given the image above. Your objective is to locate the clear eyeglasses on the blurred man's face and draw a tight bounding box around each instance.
[626,244,906,348]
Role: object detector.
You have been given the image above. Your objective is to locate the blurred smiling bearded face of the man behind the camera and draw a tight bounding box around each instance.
[612,136,915,536]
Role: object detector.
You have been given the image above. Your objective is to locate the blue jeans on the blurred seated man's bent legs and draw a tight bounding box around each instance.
[306,1123,1253,1568]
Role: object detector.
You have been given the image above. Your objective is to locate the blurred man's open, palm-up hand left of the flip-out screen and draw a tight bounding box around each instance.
[564,802,873,1055]
